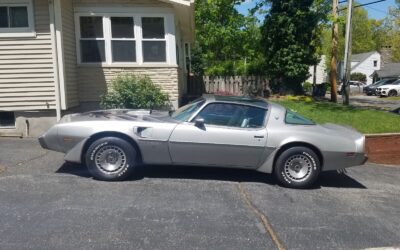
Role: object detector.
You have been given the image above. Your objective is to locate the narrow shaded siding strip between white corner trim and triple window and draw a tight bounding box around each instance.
[61,0,79,108]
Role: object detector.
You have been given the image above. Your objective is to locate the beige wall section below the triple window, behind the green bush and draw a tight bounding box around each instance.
[78,67,179,103]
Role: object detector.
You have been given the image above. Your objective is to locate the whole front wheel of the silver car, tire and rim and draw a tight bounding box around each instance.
[85,137,138,181]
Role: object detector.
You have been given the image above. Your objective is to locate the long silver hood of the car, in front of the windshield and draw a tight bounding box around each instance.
[59,109,177,123]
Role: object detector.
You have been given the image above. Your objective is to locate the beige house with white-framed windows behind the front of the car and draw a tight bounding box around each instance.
[0,0,194,136]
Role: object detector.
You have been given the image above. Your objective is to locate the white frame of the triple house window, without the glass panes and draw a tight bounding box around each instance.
[75,7,178,67]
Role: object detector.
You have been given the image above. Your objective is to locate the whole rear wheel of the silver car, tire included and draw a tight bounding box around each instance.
[274,147,321,188]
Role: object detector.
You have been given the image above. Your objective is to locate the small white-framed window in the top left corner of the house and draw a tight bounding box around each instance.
[0,0,34,37]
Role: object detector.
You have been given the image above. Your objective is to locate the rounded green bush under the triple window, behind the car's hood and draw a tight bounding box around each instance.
[100,74,169,109]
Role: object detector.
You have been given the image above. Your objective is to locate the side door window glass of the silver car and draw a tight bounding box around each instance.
[196,103,267,128]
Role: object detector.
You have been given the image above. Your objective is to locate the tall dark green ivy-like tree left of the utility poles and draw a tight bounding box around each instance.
[262,0,323,94]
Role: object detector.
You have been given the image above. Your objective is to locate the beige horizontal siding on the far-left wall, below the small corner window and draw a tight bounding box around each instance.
[0,0,55,111]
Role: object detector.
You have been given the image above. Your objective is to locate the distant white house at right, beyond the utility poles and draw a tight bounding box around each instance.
[351,51,381,84]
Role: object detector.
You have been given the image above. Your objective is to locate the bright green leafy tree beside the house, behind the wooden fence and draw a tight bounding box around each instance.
[192,0,263,75]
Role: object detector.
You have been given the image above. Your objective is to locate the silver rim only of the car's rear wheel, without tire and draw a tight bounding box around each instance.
[284,154,312,182]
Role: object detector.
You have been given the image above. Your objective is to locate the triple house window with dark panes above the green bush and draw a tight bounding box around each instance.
[76,12,176,66]
